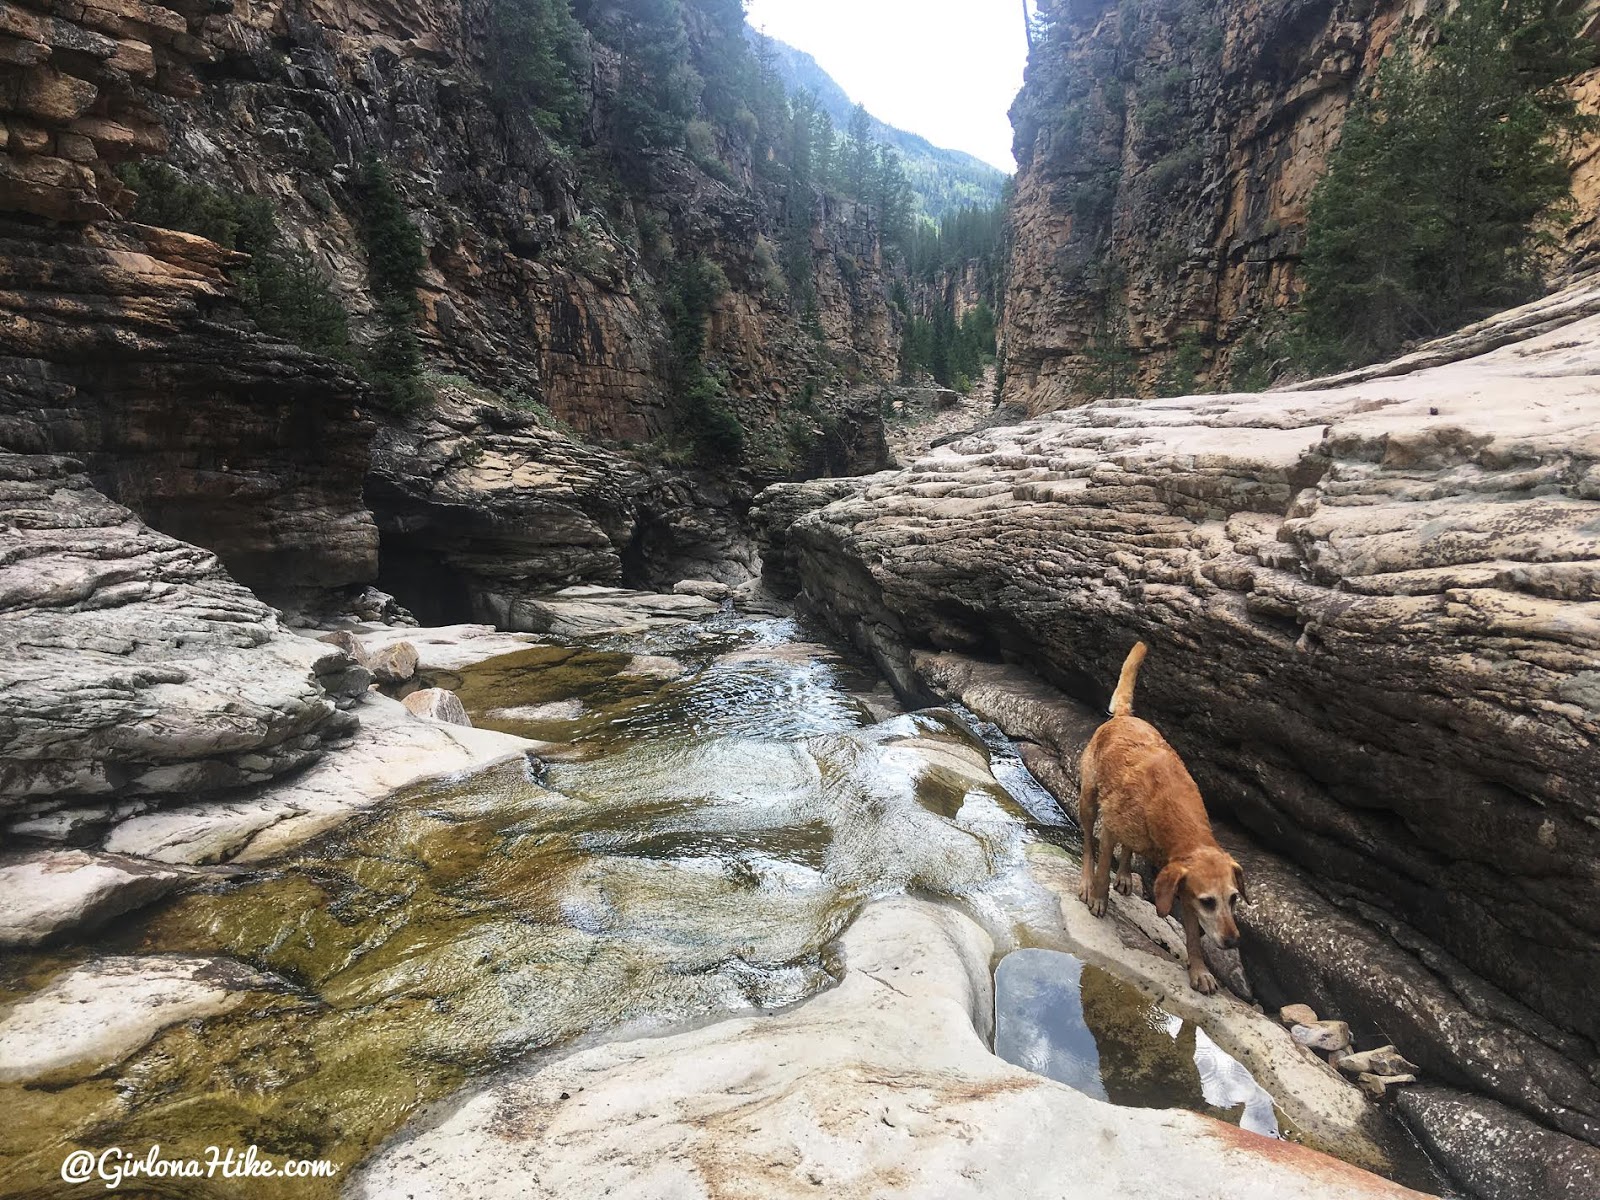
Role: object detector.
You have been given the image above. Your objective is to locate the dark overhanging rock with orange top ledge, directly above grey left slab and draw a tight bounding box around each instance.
[0,219,378,600]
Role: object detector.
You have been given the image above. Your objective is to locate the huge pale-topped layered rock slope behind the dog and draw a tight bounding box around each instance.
[760,288,1600,1195]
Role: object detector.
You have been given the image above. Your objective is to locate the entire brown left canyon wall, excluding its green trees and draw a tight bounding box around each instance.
[0,0,899,605]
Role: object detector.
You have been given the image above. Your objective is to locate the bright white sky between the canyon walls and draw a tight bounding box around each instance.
[747,0,1027,171]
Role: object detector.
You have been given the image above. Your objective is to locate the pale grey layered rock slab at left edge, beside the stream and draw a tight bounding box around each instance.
[0,454,356,822]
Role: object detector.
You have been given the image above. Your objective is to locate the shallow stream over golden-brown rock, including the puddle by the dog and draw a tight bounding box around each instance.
[0,613,1427,1198]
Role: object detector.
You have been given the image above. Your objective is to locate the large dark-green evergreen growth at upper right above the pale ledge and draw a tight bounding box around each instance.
[1302,0,1592,366]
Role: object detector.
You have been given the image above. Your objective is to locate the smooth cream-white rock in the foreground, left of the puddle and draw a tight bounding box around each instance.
[354,899,1413,1200]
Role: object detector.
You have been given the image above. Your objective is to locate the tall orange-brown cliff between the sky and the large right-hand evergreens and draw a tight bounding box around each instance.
[1005,0,1414,413]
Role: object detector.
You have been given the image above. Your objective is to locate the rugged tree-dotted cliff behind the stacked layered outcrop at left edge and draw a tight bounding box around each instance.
[140,0,896,442]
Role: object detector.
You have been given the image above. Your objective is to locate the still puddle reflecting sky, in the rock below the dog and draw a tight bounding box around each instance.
[995,949,1278,1138]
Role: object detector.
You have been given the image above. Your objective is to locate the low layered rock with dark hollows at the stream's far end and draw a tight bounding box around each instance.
[366,387,758,627]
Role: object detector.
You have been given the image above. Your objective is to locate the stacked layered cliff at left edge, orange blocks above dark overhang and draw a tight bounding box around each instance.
[0,5,378,597]
